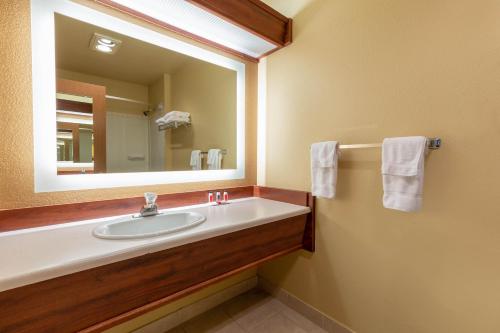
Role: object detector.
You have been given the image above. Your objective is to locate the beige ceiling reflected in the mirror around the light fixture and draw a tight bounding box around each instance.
[55,14,200,85]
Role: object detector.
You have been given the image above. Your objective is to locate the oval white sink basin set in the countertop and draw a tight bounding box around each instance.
[93,212,206,239]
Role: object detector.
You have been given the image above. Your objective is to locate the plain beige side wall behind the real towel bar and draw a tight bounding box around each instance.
[260,0,500,333]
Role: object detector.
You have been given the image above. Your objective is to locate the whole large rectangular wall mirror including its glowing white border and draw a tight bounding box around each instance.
[32,0,245,191]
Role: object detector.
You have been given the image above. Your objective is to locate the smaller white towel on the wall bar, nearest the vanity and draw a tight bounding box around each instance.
[311,141,339,199]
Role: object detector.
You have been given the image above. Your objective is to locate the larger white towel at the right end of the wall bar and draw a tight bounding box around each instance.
[382,136,427,212]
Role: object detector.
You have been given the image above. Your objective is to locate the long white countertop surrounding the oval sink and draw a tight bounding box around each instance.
[0,197,310,291]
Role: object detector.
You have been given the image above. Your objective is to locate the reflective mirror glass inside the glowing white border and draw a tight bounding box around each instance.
[55,14,236,174]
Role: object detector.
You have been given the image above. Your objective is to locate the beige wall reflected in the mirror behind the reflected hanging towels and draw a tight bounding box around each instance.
[172,61,236,170]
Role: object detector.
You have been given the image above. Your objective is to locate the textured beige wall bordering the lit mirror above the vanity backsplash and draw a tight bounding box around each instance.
[0,0,257,209]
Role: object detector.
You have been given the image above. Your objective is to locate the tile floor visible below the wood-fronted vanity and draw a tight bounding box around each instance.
[167,290,326,333]
